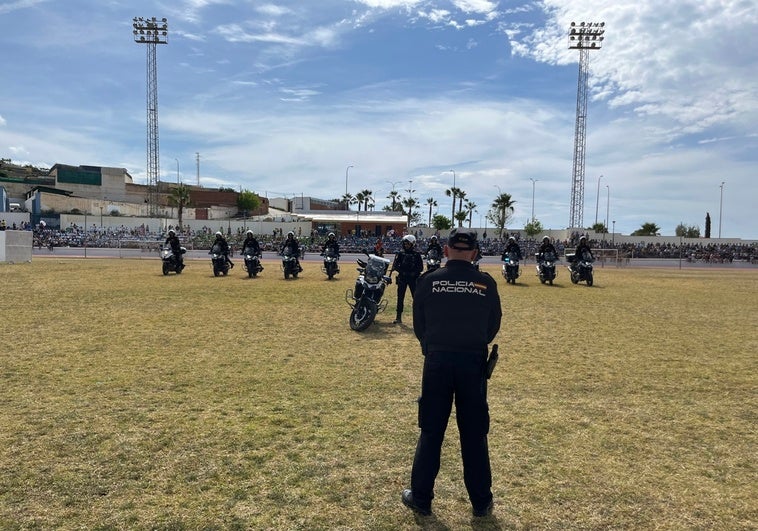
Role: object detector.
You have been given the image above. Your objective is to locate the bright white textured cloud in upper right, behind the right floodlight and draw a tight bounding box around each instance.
[506,0,758,140]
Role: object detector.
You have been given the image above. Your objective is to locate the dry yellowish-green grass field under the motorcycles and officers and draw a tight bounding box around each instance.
[0,258,758,530]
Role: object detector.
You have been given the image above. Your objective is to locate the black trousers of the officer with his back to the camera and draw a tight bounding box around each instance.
[411,352,492,509]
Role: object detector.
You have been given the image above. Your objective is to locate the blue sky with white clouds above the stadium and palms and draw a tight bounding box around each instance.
[0,0,758,239]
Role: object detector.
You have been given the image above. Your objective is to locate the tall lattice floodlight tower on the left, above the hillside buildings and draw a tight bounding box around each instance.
[132,17,168,217]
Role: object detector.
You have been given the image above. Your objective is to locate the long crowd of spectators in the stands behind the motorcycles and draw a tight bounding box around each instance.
[27,224,758,263]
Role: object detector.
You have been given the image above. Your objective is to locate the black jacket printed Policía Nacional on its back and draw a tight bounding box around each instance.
[413,260,502,354]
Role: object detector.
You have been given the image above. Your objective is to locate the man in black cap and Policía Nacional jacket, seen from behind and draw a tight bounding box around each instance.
[402,229,502,517]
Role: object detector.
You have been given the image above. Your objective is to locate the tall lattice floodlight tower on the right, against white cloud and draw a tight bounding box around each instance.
[569,22,605,228]
